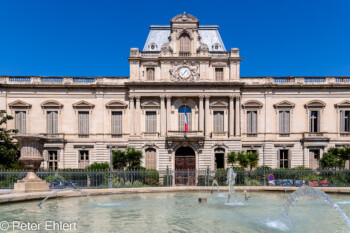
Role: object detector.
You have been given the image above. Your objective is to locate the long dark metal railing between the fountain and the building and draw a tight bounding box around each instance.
[0,169,350,189]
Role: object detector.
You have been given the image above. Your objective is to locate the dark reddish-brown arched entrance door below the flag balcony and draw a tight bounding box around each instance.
[175,147,196,185]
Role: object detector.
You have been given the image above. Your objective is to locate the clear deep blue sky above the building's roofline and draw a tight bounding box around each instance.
[0,0,350,76]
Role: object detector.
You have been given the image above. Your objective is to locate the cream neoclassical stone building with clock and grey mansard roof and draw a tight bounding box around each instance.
[0,14,350,173]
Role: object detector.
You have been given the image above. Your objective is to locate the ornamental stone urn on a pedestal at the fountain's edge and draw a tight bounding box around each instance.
[13,134,50,192]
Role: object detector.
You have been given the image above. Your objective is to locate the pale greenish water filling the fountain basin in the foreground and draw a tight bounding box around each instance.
[0,192,350,233]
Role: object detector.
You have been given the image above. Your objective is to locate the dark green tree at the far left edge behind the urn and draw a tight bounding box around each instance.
[0,110,20,168]
